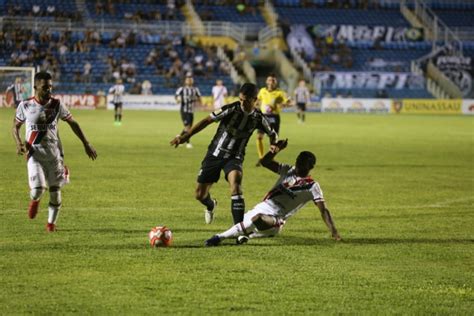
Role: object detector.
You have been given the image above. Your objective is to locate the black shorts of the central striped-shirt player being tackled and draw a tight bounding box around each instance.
[197,155,242,183]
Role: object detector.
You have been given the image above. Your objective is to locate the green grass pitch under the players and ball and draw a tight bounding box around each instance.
[0,109,474,315]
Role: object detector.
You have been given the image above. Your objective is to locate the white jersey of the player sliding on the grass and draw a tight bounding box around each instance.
[262,164,324,219]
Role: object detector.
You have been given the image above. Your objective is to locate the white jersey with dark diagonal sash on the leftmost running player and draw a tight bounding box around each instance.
[16,97,72,155]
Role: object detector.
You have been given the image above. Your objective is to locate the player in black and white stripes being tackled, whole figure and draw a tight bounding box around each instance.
[170,83,278,224]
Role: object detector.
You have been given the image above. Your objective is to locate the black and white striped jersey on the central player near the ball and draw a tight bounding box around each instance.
[207,101,278,160]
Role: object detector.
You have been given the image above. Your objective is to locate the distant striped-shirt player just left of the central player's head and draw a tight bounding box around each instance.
[175,75,201,149]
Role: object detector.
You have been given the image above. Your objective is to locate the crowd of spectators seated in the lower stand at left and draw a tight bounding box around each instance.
[0,26,230,92]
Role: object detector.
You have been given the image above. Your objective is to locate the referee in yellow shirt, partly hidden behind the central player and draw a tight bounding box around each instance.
[256,74,290,167]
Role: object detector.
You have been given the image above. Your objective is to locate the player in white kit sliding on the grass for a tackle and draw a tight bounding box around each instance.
[205,140,341,246]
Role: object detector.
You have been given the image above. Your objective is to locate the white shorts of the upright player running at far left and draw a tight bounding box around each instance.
[27,155,65,189]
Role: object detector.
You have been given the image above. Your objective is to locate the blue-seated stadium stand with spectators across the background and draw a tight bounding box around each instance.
[0,0,474,98]
